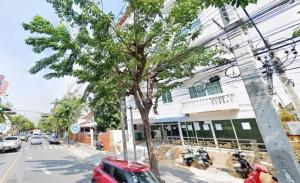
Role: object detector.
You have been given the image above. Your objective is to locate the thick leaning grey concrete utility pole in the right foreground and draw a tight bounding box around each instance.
[219,6,300,183]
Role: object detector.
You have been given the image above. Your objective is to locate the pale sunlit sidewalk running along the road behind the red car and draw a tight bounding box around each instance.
[63,143,243,183]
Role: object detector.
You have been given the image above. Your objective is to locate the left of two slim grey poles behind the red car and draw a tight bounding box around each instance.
[120,94,128,160]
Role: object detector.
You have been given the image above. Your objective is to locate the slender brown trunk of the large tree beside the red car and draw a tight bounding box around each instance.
[140,109,160,177]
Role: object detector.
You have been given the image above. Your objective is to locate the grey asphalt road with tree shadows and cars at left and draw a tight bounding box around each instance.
[0,140,94,183]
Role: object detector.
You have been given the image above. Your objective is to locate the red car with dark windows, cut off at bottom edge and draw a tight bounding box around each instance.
[91,157,165,183]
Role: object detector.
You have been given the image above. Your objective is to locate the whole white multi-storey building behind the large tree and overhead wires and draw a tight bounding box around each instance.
[123,0,300,149]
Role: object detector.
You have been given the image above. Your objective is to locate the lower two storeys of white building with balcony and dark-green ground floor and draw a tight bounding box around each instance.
[127,68,262,147]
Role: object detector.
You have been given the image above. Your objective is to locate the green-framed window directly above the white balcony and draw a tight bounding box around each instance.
[189,81,223,98]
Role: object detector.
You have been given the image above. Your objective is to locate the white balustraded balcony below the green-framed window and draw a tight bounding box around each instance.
[181,93,239,114]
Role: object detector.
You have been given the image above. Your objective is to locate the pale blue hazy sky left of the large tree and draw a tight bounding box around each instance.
[0,0,124,122]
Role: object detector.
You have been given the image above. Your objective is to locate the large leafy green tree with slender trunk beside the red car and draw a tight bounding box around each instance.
[23,0,253,175]
